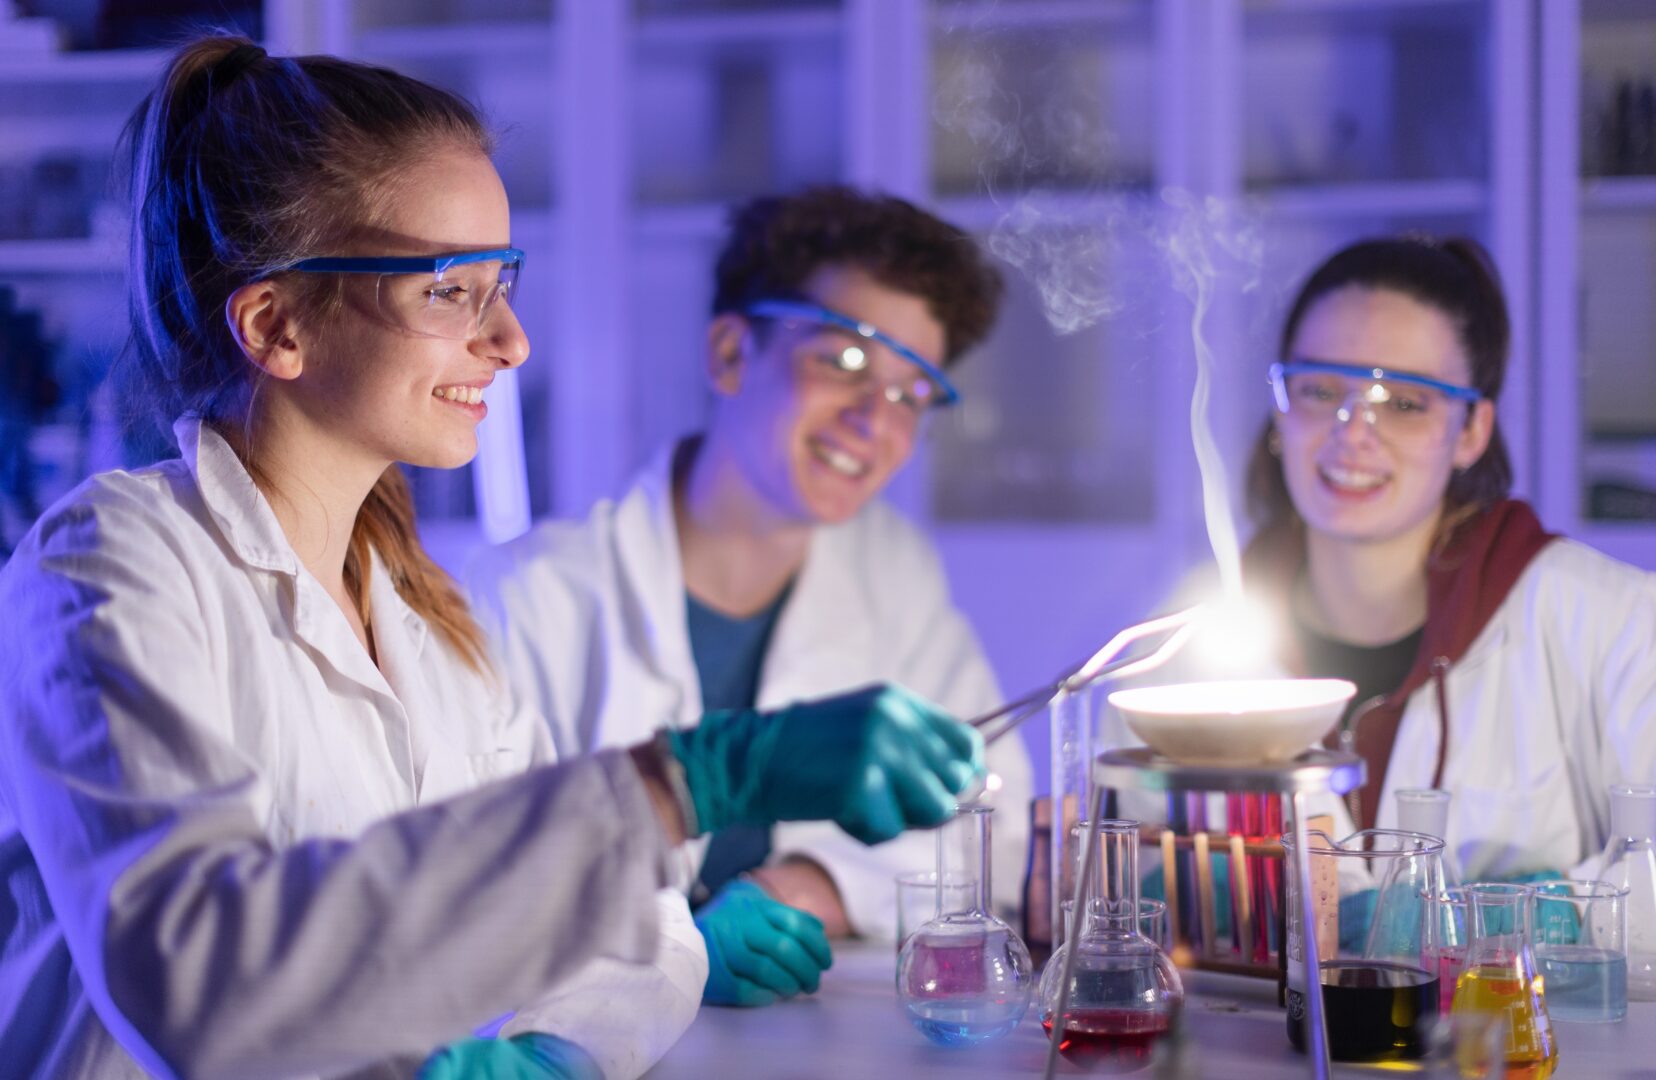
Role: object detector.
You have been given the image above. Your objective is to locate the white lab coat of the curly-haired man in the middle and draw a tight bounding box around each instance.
[469,447,1032,939]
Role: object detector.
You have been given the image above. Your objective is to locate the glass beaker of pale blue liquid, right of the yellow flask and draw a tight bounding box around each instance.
[1530,881,1628,1024]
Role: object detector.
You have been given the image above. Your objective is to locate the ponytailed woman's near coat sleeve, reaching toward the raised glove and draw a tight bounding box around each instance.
[0,497,666,1078]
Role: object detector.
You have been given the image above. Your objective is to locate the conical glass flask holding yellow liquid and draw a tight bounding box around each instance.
[1454,885,1558,1080]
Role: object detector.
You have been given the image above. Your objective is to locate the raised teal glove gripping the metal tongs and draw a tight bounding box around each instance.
[671,686,984,843]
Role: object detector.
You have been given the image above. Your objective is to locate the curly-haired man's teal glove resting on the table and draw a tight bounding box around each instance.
[696,881,833,1005]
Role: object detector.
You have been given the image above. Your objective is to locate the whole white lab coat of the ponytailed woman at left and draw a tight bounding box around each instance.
[0,419,705,1080]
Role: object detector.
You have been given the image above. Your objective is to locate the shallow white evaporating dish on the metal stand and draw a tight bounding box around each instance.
[1110,679,1356,765]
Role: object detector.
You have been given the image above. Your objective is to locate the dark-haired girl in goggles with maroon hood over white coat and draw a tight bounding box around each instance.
[1244,237,1656,878]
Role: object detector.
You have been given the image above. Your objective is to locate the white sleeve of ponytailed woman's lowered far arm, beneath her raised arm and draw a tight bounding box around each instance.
[500,888,707,1080]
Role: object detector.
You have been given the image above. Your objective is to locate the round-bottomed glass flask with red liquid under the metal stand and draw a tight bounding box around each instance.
[1040,820,1184,1070]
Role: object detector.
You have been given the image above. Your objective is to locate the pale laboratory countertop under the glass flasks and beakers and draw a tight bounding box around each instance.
[649,943,1656,1080]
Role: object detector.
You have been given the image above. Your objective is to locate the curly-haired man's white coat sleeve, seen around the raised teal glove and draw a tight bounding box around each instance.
[773,523,1033,941]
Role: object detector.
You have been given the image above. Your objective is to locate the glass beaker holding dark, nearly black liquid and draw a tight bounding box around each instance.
[1282,828,1442,1062]
